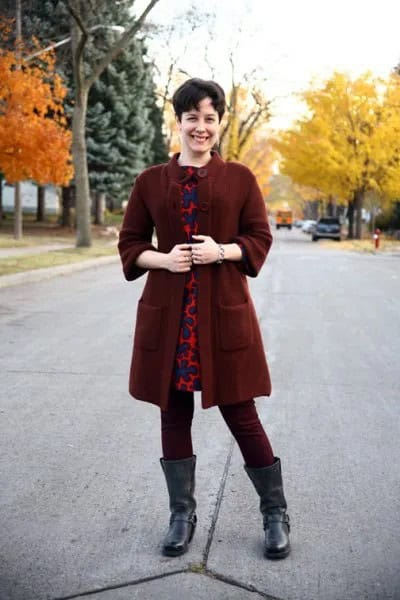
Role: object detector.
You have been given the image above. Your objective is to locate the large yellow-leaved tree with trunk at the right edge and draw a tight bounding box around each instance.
[275,73,400,238]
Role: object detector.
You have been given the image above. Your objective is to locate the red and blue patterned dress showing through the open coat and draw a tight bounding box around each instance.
[173,167,201,392]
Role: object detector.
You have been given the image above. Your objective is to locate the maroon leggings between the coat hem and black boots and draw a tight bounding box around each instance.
[161,390,274,468]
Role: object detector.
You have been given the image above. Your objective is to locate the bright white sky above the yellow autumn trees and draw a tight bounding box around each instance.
[134,0,400,128]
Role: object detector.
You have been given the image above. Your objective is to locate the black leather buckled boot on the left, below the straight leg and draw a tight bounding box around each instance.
[160,456,197,556]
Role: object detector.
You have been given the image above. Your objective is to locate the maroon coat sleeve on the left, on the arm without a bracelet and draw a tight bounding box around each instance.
[118,176,157,281]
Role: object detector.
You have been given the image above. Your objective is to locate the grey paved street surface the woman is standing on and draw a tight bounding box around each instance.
[0,230,400,600]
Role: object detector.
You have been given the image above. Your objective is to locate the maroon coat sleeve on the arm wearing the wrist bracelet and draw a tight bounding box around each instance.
[232,174,272,277]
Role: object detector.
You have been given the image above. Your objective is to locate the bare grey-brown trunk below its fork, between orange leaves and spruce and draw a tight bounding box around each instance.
[72,90,92,248]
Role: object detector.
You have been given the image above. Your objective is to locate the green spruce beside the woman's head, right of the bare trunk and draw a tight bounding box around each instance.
[86,35,167,210]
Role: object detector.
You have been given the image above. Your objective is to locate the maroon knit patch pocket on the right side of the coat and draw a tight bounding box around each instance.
[219,302,253,350]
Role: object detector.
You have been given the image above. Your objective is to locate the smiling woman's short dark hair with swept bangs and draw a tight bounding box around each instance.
[172,77,225,121]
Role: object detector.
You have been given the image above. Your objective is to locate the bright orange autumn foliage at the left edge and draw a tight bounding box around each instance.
[0,27,73,185]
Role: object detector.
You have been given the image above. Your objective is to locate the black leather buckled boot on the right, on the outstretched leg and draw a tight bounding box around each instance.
[244,457,290,558]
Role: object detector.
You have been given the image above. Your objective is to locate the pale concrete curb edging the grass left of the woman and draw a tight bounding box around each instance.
[0,255,120,288]
